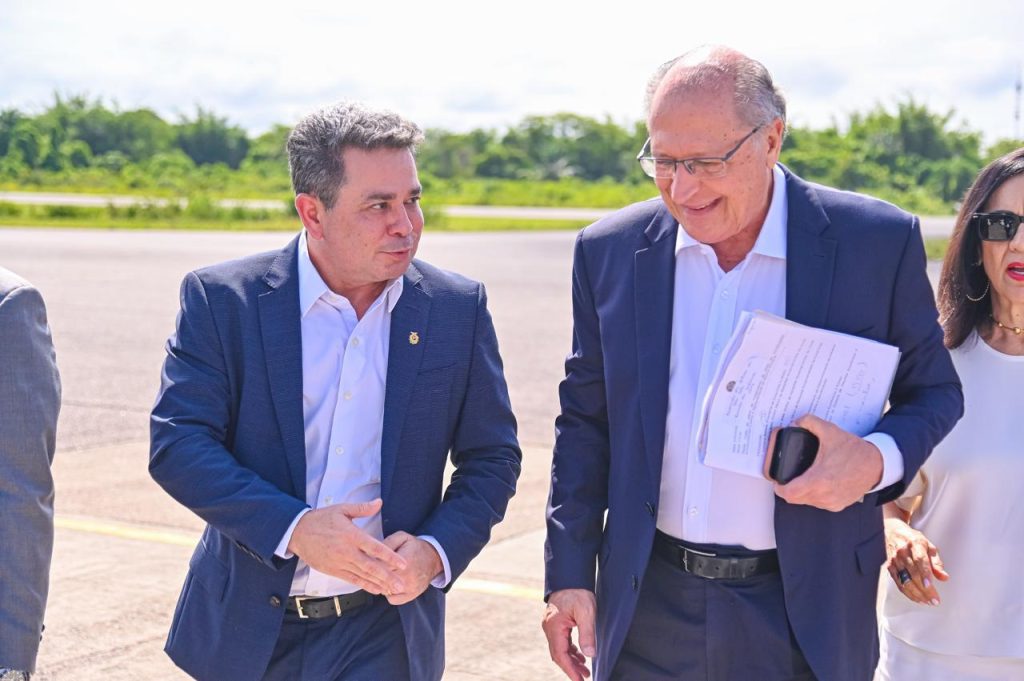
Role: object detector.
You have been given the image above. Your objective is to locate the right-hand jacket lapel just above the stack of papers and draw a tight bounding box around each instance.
[783,168,836,327]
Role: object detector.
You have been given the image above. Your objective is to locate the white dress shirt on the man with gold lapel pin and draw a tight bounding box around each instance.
[276,231,451,596]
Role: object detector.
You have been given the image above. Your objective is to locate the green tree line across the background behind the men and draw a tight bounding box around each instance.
[0,95,1024,213]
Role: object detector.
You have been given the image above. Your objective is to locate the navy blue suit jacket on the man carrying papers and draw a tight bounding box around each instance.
[545,171,963,681]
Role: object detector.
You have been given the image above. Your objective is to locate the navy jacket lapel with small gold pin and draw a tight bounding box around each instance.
[381,264,430,499]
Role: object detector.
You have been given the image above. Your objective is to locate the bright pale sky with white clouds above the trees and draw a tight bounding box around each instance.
[0,0,1024,141]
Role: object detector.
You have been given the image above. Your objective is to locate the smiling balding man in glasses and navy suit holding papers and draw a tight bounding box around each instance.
[544,47,963,681]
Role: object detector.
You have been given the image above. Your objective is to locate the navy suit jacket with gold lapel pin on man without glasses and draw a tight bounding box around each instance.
[150,235,521,681]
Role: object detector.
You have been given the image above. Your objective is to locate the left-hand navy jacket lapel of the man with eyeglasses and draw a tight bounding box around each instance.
[634,207,678,480]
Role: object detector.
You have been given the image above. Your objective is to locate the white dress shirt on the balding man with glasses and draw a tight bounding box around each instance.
[657,166,903,550]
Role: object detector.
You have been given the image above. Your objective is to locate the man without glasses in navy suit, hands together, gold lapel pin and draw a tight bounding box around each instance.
[150,103,521,681]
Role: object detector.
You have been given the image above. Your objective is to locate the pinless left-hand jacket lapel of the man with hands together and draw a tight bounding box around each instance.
[259,238,306,499]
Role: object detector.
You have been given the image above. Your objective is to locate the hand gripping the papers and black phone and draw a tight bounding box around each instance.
[764,414,882,512]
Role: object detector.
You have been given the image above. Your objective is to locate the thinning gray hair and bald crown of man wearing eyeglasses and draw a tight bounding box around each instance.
[644,46,785,135]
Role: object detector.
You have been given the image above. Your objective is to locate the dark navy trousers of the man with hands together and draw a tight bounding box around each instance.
[263,596,409,681]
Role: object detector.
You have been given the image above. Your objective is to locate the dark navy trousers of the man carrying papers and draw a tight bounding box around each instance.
[610,545,814,681]
